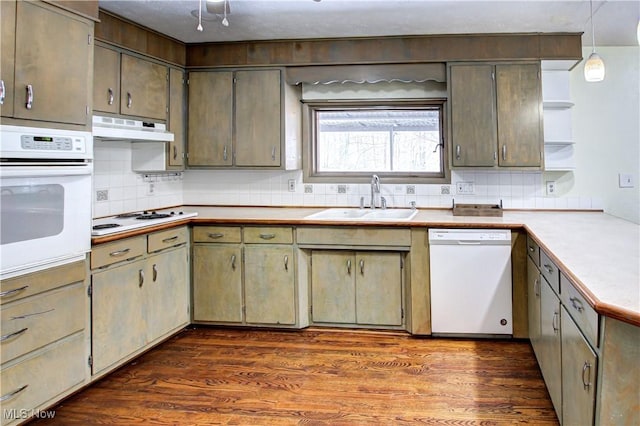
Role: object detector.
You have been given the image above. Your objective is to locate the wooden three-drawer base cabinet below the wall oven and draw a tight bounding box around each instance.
[0,261,89,425]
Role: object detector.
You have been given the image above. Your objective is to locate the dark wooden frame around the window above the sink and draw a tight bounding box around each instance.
[302,98,451,184]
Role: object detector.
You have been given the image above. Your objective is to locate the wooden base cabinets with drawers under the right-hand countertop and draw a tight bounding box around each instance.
[527,241,600,426]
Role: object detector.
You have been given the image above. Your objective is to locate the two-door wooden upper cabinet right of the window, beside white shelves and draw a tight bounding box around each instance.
[449,63,542,169]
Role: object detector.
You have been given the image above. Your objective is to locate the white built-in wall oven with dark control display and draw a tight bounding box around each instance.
[0,125,93,279]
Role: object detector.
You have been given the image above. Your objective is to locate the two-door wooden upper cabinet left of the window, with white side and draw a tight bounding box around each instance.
[187,69,301,169]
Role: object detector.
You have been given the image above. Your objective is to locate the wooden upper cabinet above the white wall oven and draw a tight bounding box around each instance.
[0,1,93,126]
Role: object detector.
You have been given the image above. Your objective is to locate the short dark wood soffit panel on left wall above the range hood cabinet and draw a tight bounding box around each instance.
[95,10,186,67]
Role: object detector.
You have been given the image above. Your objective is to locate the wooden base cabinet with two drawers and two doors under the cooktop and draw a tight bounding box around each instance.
[91,227,190,375]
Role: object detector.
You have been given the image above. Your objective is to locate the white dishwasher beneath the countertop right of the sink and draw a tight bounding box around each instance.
[429,228,513,337]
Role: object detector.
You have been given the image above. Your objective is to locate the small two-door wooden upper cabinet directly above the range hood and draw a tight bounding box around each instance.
[93,46,169,121]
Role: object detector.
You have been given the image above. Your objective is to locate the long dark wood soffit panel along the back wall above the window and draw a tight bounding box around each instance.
[186,33,582,68]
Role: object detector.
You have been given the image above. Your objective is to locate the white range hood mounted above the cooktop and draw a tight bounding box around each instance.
[92,115,174,142]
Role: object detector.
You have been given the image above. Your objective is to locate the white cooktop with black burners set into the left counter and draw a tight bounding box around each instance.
[91,210,198,236]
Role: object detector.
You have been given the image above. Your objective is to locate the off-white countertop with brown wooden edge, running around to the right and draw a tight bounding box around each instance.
[94,206,640,326]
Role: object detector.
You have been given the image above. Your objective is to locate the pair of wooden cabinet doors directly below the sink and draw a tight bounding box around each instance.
[311,250,404,326]
